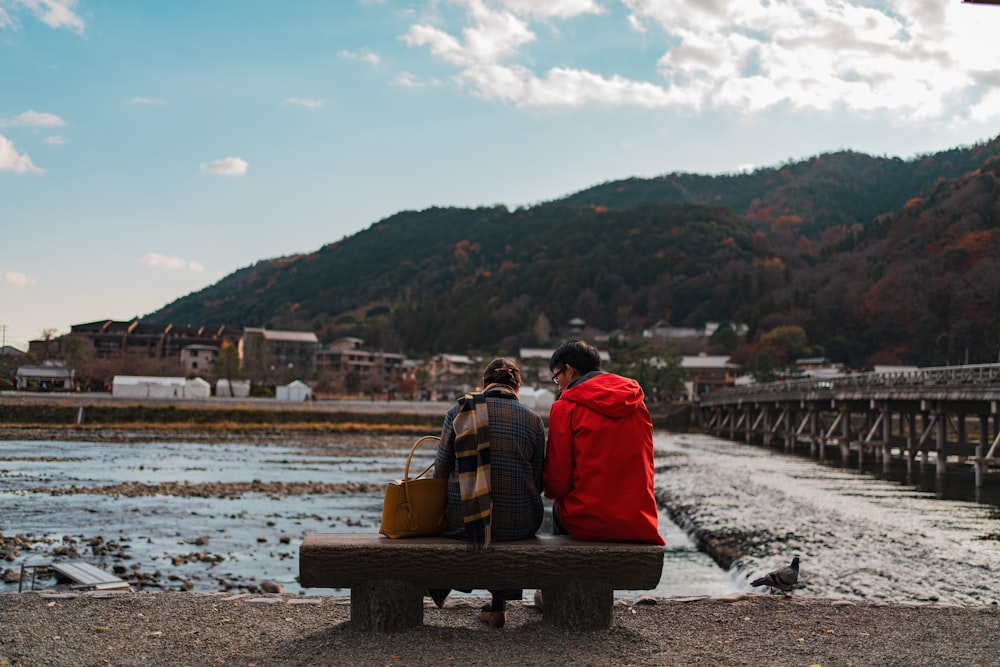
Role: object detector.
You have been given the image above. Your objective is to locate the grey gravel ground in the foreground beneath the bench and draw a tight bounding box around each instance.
[0,593,1000,667]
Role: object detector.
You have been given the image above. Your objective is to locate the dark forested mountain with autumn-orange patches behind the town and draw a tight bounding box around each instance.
[147,134,1000,366]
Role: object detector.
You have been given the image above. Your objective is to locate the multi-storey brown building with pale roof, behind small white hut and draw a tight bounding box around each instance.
[239,327,320,385]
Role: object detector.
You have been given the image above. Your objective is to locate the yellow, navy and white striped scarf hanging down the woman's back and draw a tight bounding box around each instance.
[453,384,517,551]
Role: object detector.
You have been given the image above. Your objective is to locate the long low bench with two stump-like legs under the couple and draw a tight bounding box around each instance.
[299,533,663,632]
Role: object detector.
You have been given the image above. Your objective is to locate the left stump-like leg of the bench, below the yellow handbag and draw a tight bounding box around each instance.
[351,579,424,632]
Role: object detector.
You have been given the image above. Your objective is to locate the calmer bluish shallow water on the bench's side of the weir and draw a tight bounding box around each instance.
[0,436,736,596]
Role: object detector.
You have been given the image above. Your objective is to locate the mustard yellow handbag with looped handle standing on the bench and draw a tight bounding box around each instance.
[378,435,448,537]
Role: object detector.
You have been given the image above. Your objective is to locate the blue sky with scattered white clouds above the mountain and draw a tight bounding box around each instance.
[0,0,1000,350]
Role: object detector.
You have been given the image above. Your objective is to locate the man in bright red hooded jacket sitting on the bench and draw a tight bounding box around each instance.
[543,340,664,544]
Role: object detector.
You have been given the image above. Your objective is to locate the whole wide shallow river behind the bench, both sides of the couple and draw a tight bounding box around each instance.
[0,432,1000,603]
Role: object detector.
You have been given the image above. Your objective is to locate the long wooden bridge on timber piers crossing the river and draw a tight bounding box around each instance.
[693,364,1000,486]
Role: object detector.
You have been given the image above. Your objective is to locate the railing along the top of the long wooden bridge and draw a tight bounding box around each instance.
[698,364,1000,403]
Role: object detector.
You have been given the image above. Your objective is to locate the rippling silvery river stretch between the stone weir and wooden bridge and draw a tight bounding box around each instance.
[656,435,1000,604]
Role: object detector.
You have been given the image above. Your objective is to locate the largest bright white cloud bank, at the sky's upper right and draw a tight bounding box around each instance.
[397,0,1000,123]
